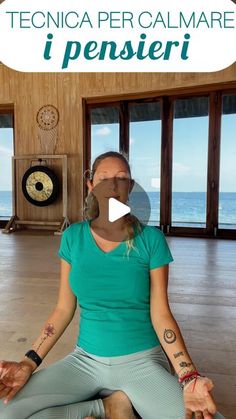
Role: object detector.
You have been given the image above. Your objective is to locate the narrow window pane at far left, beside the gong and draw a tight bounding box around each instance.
[0,114,13,218]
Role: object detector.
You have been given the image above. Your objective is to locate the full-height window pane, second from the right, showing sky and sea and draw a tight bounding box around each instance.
[172,97,209,227]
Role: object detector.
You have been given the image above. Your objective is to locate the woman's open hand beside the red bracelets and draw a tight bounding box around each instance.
[183,377,216,419]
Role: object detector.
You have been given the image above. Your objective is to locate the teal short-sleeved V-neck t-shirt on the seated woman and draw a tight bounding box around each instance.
[58,221,174,357]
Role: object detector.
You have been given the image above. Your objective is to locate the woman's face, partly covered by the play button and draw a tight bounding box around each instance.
[87,157,134,205]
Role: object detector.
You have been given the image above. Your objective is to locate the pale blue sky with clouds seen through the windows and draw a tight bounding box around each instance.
[0,114,236,192]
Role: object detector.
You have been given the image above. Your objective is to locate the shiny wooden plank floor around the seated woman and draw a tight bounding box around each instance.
[0,231,236,419]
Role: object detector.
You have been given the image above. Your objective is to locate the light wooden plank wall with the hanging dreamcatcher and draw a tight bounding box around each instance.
[0,63,236,222]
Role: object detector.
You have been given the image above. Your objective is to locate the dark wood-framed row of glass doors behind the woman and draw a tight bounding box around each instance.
[85,85,236,238]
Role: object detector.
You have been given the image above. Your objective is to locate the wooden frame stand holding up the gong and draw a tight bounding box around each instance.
[2,154,70,234]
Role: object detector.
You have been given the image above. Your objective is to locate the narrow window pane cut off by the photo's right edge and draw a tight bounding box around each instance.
[219,95,236,229]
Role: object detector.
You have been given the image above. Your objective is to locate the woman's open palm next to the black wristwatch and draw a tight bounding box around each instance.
[0,361,34,404]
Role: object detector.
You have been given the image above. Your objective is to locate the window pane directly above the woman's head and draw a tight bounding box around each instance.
[91,106,120,162]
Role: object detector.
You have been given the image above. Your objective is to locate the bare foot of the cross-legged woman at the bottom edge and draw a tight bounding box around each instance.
[102,390,136,419]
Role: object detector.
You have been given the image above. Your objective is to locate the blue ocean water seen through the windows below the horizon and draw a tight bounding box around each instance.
[0,191,236,229]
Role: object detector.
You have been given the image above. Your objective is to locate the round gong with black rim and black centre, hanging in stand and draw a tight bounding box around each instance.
[22,166,59,207]
